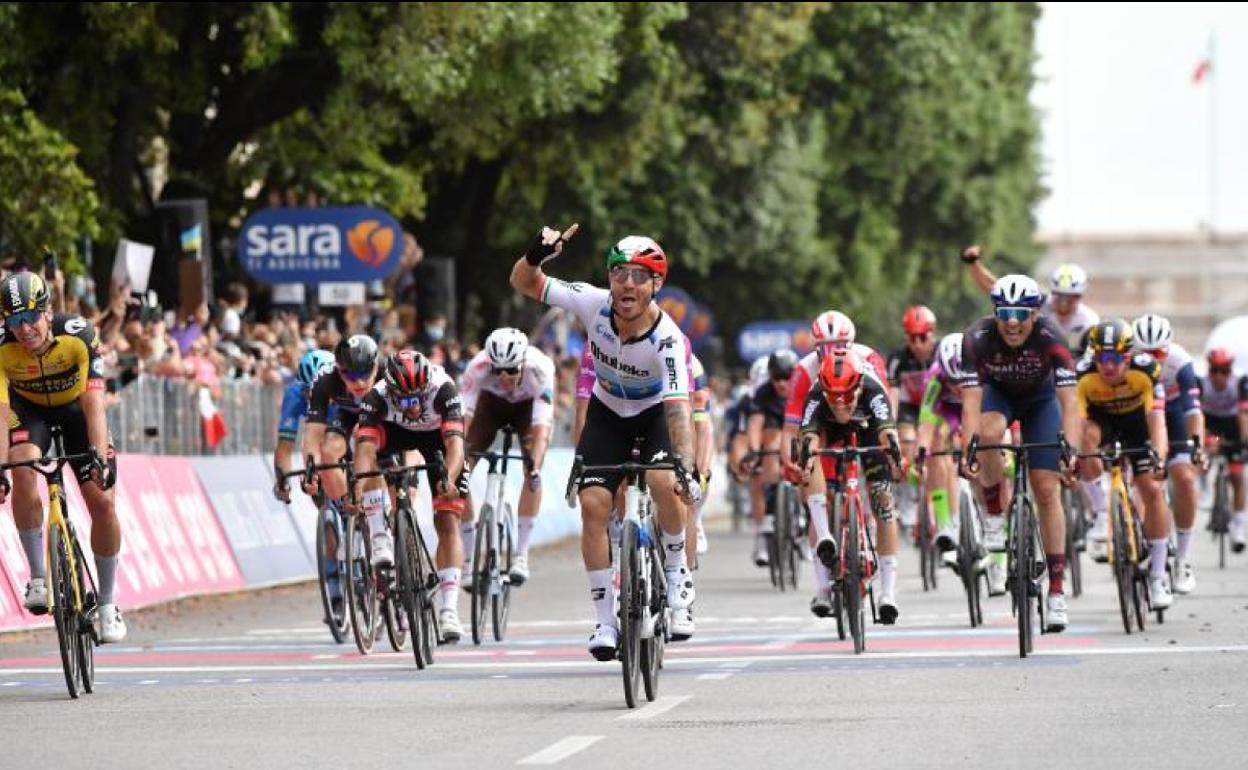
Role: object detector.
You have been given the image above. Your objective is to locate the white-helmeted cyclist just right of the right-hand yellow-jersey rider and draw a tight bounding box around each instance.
[1131,313,1204,594]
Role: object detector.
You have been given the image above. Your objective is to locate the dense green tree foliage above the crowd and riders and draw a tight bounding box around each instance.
[0,2,1043,344]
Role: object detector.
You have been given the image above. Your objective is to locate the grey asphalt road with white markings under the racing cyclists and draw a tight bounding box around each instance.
[0,506,1248,769]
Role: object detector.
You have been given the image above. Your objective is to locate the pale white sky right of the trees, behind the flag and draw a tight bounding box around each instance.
[1032,2,1248,235]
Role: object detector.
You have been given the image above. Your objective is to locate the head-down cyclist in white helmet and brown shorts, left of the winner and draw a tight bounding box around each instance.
[461,327,555,585]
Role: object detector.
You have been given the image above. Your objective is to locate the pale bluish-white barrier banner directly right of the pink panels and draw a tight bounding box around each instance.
[191,454,316,587]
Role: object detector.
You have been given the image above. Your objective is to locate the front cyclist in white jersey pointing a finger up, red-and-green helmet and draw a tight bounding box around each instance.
[510,225,700,660]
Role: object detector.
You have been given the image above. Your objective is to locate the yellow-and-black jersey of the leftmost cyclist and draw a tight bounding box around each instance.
[0,314,104,407]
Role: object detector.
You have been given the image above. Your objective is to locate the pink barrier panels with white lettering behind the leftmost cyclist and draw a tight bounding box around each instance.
[0,454,243,630]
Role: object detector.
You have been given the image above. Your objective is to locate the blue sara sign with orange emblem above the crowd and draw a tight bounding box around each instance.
[238,206,403,283]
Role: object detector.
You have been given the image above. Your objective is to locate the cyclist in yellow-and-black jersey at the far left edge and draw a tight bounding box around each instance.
[0,272,126,643]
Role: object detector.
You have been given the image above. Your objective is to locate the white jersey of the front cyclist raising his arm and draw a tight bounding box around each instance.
[542,277,689,417]
